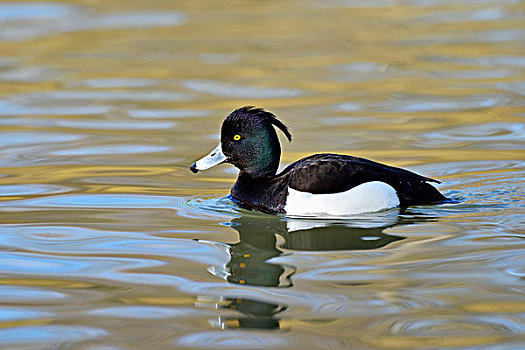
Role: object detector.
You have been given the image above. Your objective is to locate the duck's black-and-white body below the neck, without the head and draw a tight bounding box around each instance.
[231,153,446,215]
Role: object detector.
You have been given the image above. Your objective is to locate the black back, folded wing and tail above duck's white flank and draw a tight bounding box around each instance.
[279,154,446,206]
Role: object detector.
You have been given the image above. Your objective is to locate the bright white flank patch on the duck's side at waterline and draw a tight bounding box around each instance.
[284,181,399,216]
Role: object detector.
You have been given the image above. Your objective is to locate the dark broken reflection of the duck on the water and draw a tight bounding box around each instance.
[201,213,429,329]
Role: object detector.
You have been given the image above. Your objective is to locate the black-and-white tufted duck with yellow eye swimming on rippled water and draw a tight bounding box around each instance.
[190,106,447,217]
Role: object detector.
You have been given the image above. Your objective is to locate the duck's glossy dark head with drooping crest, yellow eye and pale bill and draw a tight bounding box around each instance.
[190,106,292,178]
